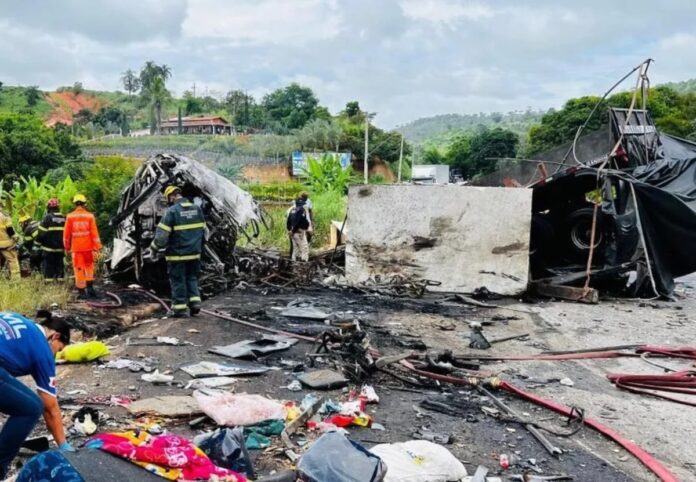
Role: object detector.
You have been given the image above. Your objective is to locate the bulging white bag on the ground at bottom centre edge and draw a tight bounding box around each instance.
[371,440,467,482]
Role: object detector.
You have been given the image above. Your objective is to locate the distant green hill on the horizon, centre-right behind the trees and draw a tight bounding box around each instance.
[396,110,544,147]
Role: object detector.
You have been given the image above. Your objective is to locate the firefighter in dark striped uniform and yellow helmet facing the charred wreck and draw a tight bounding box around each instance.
[150,186,206,318]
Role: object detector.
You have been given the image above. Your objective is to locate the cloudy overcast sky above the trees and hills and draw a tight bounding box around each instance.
[0,0,696,128]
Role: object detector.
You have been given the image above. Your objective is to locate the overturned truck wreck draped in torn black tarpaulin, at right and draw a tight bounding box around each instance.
[498,109,696,297]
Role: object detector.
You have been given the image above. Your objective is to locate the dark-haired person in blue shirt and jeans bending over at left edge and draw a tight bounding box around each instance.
[0,310,72,480]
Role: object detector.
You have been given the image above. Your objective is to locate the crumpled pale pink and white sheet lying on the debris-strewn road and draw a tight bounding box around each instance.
[193,390,285,427]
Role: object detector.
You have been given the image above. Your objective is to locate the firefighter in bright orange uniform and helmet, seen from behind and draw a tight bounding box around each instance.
[63,194,102,298]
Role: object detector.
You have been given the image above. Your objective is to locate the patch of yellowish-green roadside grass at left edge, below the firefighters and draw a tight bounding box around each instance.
[0,276,70,316]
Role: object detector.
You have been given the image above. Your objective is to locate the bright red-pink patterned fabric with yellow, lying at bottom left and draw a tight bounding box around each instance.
[90,433,246,482]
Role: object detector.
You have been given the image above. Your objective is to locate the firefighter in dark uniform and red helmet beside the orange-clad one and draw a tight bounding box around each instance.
[37,198,65,280]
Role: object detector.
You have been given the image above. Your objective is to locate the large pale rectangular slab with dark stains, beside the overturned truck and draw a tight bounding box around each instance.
[346,185,532,295]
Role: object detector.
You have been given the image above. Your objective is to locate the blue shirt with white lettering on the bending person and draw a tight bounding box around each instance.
[0,311,56,397]
